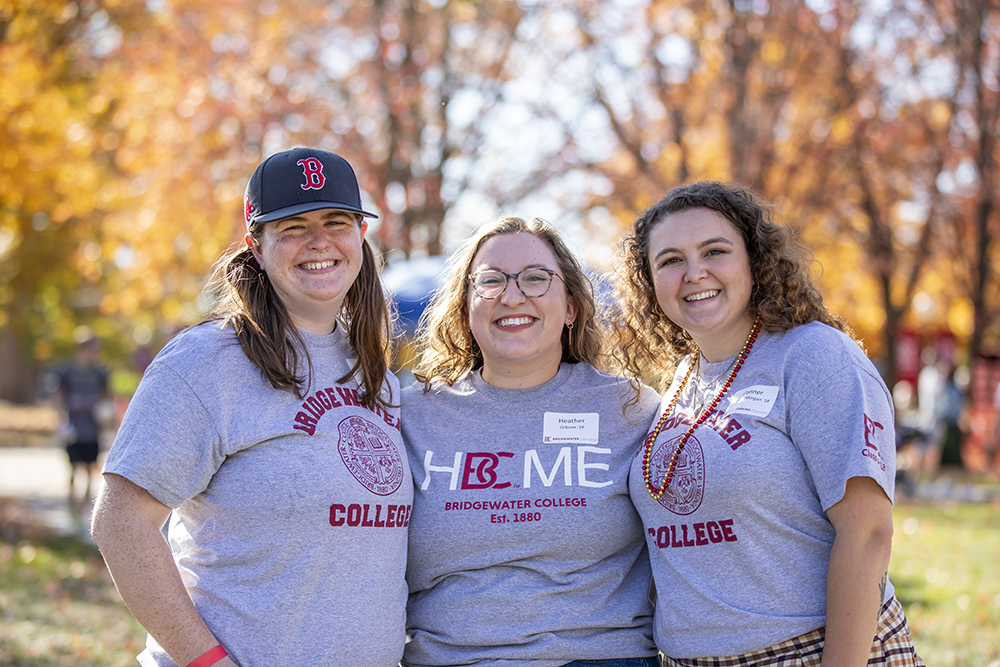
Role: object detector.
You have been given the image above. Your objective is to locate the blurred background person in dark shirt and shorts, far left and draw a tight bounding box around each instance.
[56,336,109,511]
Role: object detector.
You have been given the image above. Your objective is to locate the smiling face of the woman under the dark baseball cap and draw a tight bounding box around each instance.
[246,209,368,334]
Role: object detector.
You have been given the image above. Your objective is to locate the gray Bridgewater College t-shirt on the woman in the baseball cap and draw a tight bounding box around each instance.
[104,323,413,667]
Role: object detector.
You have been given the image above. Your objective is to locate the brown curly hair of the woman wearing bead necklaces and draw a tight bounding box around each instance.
[613,181,854,391]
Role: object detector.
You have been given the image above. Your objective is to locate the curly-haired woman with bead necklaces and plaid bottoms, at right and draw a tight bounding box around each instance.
[618,182,923,667]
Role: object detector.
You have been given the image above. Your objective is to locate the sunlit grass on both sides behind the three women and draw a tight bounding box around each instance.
[0,499,1000,667]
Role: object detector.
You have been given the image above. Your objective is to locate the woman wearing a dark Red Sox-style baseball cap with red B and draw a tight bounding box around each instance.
[92,148,413,667]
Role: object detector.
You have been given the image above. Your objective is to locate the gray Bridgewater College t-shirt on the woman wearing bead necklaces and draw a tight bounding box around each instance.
[630,323,895,658]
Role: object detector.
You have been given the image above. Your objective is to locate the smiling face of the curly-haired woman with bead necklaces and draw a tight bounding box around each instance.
[649,208,753,361]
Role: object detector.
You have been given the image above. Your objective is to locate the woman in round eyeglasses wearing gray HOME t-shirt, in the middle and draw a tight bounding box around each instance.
[402,217,660,667]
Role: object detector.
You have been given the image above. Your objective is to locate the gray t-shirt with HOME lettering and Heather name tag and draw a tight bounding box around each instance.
[403,363,659,667]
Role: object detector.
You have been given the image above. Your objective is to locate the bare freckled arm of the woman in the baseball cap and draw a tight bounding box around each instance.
[91,474,225,667]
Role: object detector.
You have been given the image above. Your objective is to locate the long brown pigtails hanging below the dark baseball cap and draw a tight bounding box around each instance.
[207,218,393,408]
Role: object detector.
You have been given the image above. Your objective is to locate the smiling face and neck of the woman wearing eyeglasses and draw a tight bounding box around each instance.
[466,232,577,389]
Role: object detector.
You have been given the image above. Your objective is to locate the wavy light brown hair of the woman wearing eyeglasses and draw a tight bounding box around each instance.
[413,216,604,391]
